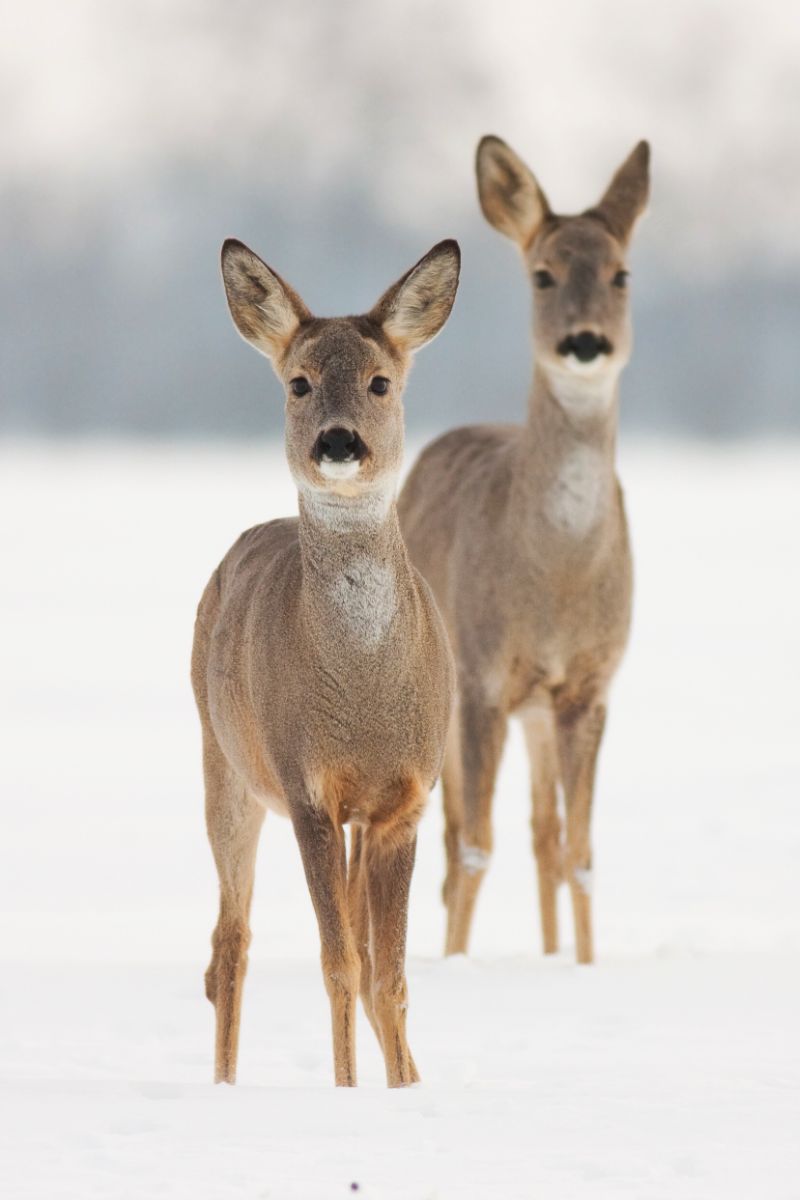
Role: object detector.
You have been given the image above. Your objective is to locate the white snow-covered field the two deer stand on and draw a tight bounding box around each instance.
[0,443,800,1200]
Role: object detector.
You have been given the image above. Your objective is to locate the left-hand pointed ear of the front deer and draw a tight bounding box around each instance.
[222,238,311,359]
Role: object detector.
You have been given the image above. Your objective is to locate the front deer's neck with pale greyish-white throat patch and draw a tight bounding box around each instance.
[300,487,409,652]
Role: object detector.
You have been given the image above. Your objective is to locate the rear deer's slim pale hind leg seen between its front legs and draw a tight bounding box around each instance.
[523,707,564,954]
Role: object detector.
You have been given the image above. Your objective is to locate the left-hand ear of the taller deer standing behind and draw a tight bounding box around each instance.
[475,137,551,250]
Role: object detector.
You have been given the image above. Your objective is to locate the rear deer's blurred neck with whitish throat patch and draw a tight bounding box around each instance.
[518,366,619,552]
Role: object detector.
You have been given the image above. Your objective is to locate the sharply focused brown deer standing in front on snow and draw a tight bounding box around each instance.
[192,239,461,1087]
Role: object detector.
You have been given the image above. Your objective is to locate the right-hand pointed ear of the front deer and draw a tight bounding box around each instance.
[369,239,461,350]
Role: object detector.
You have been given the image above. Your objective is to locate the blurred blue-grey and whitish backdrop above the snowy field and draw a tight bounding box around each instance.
[0,0,800,438]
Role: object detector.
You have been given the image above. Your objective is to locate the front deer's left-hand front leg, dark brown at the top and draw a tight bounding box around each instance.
[290,794,360,1087]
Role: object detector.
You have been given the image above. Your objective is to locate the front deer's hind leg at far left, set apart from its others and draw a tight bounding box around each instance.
[203,733,264,1084]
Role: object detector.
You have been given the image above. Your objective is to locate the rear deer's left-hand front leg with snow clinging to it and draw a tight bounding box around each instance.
[445,696,506,954]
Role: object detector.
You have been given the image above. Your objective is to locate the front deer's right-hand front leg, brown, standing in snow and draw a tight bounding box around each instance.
[366,830,420,1087]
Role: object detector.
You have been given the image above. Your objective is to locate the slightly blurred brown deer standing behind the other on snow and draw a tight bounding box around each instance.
[398,136,649,964]
